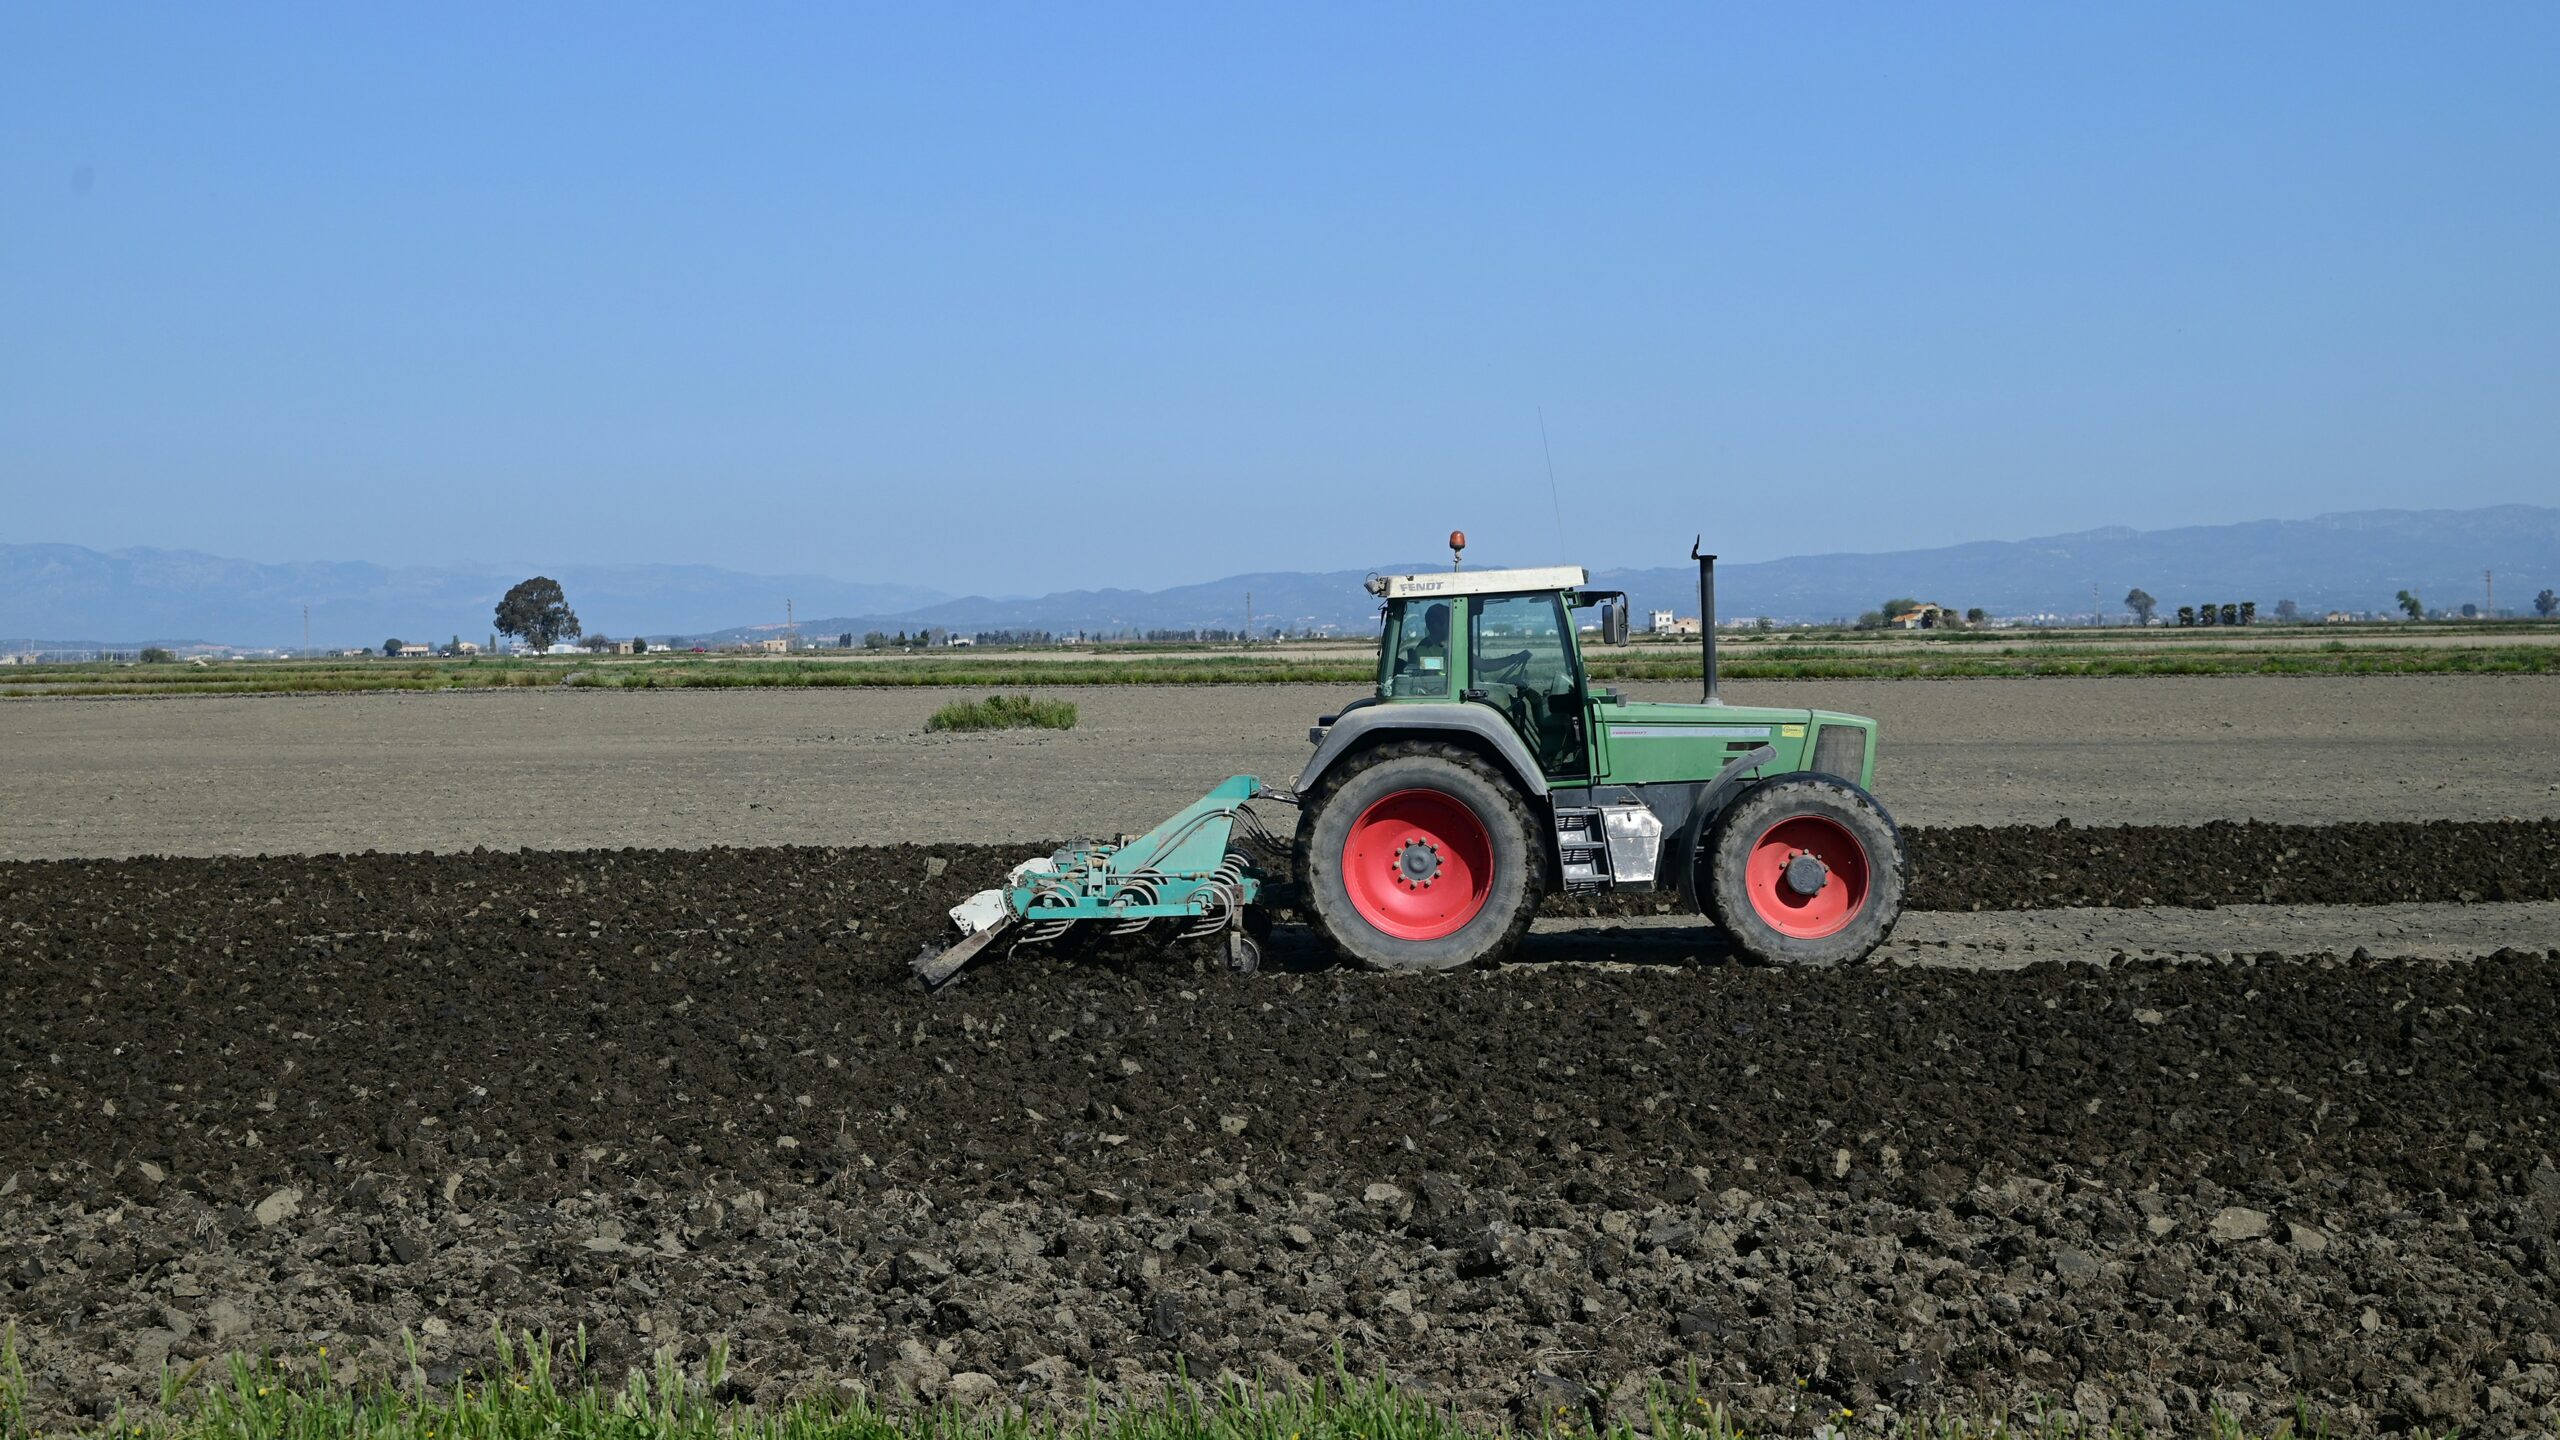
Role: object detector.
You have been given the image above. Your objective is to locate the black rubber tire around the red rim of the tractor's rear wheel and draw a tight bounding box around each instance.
[1295,740,1546,971]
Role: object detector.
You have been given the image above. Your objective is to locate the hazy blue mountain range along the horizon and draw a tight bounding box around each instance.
[0,505,2560,651]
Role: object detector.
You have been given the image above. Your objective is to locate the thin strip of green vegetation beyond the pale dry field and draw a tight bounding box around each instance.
[20,625,2560,697]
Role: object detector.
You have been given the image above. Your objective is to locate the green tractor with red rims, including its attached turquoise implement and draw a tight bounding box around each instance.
[914,533,1907,986]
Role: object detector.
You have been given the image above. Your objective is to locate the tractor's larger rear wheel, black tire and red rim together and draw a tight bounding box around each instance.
[1295,740,1546,971]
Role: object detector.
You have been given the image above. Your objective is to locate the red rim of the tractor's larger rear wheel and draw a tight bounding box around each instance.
[1341,789,1492,940]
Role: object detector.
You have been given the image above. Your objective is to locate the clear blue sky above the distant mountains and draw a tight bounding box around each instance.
[0,5,2560,592]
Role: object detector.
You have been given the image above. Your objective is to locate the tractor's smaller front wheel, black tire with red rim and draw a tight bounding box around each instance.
[1697,774,1910,966]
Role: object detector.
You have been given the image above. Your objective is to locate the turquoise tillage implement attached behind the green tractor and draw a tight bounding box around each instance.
[914,774,1275,989]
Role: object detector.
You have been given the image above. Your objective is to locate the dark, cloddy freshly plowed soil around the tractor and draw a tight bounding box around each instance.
[0,822,2560,1432]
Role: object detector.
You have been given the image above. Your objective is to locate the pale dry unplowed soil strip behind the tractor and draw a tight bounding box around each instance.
[0,676,2560,858]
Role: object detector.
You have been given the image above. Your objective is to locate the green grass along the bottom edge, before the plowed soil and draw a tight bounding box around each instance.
[0,1327,2429,1440]
